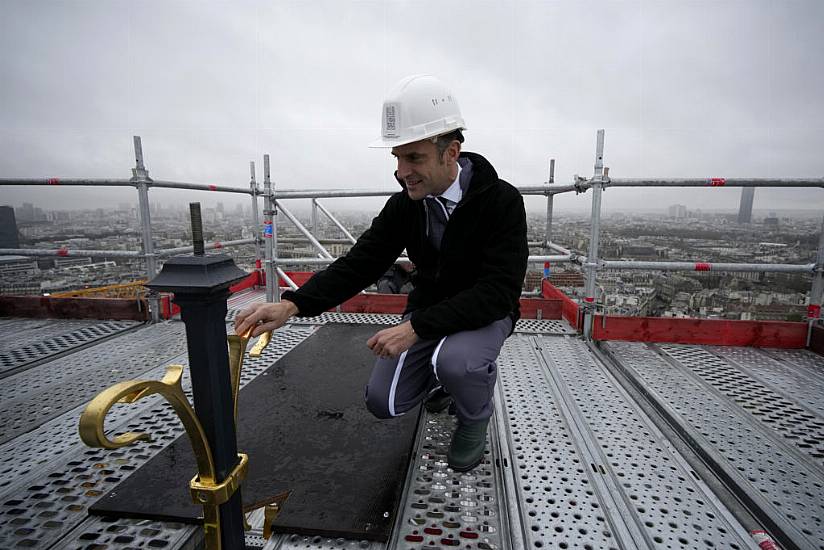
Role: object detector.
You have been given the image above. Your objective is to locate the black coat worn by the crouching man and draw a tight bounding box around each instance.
[283,153,529,339]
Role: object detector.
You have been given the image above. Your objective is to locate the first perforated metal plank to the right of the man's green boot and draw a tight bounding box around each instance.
[498,336,619,550]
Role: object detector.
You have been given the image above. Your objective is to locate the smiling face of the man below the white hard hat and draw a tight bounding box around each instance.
[392,139,460,201]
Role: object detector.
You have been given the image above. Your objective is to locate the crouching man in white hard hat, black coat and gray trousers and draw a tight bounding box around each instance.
[235,75,529,471]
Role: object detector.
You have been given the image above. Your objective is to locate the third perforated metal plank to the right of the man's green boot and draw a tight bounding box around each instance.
[604,342,824,548]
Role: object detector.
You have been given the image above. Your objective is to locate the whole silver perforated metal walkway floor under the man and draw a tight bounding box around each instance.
[0,292,824,550]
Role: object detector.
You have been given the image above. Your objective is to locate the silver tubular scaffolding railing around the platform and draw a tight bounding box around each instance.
[0,134,824,339]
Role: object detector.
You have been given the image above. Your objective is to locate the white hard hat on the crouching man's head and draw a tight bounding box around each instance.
[369,74,466,147]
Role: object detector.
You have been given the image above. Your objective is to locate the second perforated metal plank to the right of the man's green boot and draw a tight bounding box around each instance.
[538,337,756,548]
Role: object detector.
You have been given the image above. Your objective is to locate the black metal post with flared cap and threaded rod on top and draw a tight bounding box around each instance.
[146,205,247,550]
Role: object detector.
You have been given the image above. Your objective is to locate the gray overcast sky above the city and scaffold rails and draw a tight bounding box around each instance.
[0,0,824,217]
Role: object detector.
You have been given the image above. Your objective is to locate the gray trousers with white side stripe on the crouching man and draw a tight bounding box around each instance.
[365,317,512,422]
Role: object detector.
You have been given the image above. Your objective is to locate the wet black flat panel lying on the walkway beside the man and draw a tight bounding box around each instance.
[90,324,419,542]
